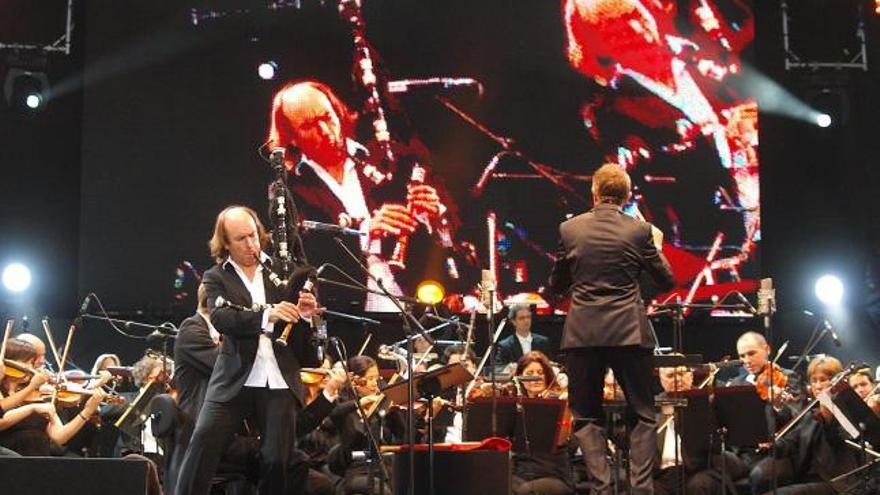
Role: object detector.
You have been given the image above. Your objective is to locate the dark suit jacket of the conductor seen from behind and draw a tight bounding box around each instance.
[550,204,674,349]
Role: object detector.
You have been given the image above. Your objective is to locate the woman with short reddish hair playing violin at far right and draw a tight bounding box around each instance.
[767,356,859,495]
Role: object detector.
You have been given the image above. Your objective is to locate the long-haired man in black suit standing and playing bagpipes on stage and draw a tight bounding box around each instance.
[176,206,319,495]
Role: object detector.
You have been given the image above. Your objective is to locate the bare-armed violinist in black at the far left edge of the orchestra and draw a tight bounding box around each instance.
[0,339,105,456]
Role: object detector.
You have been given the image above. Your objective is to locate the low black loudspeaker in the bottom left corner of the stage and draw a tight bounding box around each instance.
[0,457,149,495]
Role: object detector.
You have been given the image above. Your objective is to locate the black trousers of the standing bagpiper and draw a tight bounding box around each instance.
[175,387,298,495]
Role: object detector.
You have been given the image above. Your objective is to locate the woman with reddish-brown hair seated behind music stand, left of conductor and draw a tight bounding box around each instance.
[511,351,574,495]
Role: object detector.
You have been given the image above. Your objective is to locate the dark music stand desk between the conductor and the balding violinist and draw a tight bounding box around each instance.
[714,385,770,447]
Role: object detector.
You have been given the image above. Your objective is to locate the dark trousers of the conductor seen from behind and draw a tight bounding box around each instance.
[565,346,657,495]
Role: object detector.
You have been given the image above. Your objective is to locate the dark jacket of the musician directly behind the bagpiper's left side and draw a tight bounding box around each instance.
[174,314,220,421]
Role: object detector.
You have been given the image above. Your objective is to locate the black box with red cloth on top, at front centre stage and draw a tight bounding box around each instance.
[394,450,510,495]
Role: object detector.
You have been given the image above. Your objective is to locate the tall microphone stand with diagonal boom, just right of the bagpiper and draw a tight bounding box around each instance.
[333,236,435,495]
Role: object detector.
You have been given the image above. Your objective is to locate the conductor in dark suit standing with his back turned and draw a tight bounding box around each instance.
[550,164,674,495]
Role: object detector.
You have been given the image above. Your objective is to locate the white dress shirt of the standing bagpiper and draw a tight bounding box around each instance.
[227,259,289,390]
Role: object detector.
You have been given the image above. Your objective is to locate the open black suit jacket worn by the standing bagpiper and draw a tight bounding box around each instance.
[202,263,319,405]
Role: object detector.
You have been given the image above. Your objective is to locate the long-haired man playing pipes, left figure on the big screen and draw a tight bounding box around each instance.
[268,81,446,311]
